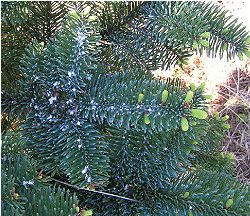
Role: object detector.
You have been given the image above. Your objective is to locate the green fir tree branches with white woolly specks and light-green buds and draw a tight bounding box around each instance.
[1,1,250,216]
